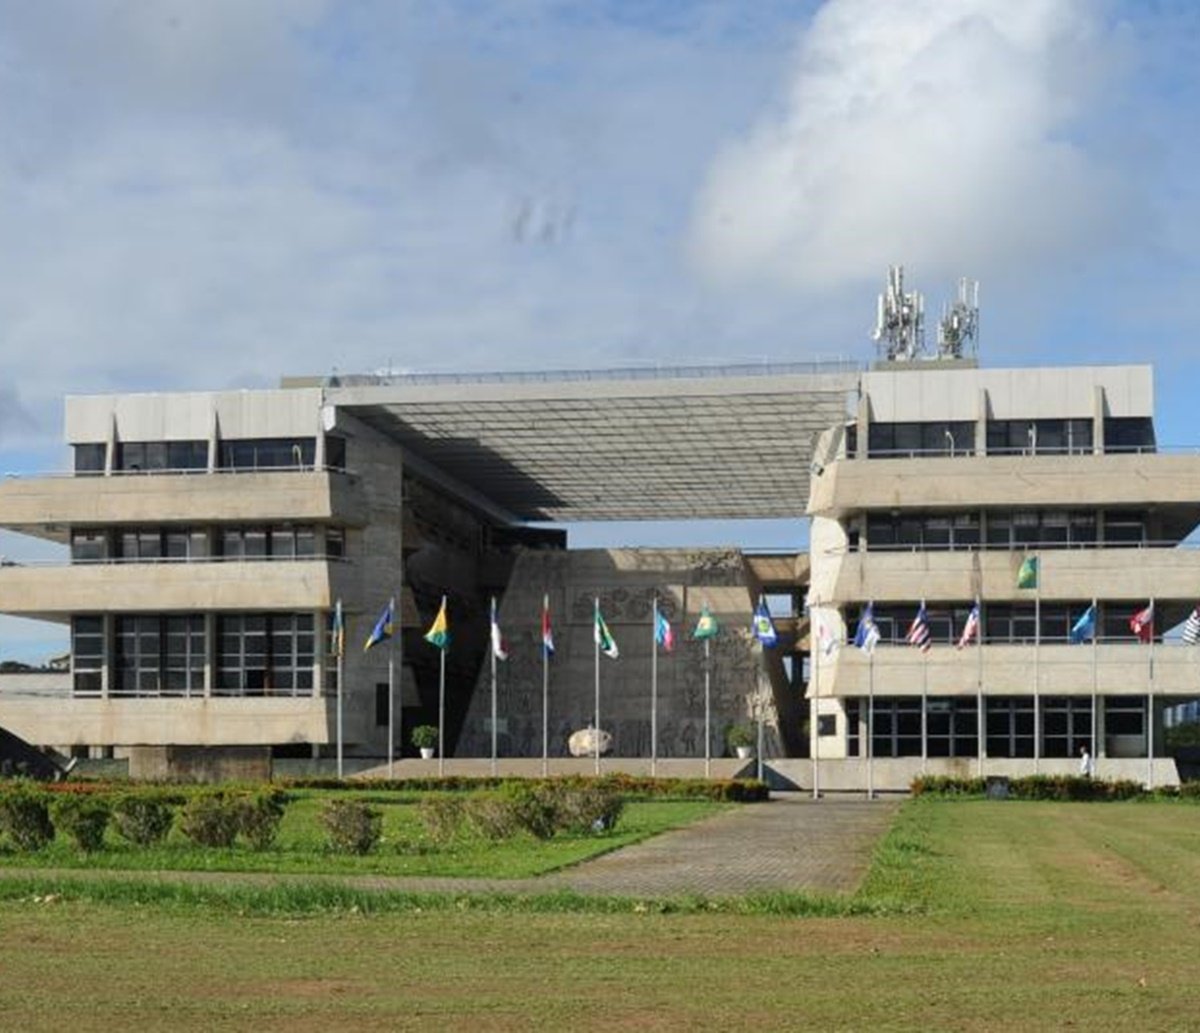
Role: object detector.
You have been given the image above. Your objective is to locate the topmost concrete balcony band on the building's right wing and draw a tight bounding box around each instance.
[809,454,1200,517]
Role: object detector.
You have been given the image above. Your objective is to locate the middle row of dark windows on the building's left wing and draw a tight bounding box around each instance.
[71,524,346,563]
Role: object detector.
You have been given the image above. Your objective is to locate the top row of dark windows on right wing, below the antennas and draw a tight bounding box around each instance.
[846,416,1154,458]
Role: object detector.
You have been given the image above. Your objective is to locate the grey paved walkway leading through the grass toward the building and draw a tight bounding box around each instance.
[0,793,899,897]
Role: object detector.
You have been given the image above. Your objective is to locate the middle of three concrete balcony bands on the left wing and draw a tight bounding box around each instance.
[0,559,360,620]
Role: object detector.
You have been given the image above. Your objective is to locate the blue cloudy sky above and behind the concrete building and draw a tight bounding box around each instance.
[0,0,1200,657]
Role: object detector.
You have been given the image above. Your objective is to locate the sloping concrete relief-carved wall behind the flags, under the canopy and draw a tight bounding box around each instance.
[457,549,779,757]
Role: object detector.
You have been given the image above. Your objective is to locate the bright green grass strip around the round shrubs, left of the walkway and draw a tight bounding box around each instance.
[0,789,730,878]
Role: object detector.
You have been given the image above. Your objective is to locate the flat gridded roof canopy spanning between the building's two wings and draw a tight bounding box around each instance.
[326,362,858,522]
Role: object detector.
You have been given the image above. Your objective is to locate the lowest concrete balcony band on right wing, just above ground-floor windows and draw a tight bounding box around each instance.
[809,642,1200,698]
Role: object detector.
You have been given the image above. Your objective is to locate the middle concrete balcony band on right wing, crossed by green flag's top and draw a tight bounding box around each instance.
[814,546,1200,603]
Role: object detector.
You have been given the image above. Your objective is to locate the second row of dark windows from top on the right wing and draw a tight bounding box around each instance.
[866,510,1150,551]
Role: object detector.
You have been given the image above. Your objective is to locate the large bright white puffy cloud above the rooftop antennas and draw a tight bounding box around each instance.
[690,0,1144,290]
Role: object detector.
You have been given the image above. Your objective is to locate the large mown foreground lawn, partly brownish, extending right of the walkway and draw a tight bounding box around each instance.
[0,800,1200,1031]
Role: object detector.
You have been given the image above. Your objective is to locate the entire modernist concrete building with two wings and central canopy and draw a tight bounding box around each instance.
[0,350,1200,789]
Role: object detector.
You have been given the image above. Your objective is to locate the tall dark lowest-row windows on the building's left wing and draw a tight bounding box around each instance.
[71,613,316,696]
